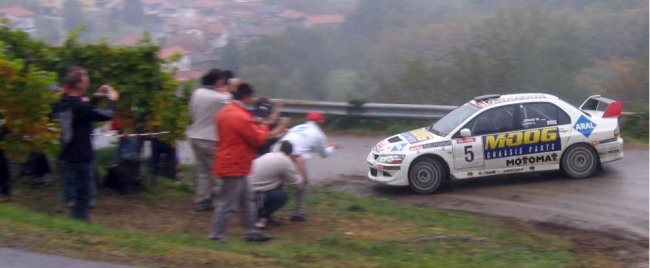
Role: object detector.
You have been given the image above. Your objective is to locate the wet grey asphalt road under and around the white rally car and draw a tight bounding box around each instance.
[308,136,649,241]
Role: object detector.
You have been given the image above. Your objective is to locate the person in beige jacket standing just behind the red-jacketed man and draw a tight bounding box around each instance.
[187,69,232,211]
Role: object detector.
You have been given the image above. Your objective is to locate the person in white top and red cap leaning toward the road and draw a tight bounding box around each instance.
[281,112,340,221]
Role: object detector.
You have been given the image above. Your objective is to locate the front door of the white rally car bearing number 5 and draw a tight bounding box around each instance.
[452,105,517,173]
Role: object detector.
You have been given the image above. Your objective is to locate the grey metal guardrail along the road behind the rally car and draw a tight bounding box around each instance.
[278,100,457,119]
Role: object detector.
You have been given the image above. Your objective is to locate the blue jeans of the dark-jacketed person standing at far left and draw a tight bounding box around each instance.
[63,162,93,221]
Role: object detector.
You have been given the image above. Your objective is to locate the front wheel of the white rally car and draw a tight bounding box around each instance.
[409,158,447,195]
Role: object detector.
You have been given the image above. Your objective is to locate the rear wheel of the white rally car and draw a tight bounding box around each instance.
[561,144,600,179]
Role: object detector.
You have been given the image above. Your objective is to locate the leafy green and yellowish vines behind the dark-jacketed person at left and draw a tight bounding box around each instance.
[0,26,189,158]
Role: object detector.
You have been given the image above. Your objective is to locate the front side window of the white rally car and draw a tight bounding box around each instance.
[464,105,518,136]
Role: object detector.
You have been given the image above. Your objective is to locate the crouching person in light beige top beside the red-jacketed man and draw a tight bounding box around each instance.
[248,141,305,228]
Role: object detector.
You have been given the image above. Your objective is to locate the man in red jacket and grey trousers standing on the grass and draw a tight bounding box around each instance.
[210,83,271,242]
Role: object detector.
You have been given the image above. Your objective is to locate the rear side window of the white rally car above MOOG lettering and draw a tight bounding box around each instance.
[519,103,571,129]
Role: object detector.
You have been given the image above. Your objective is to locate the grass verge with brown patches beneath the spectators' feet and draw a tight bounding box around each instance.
[0,177,584,267]
